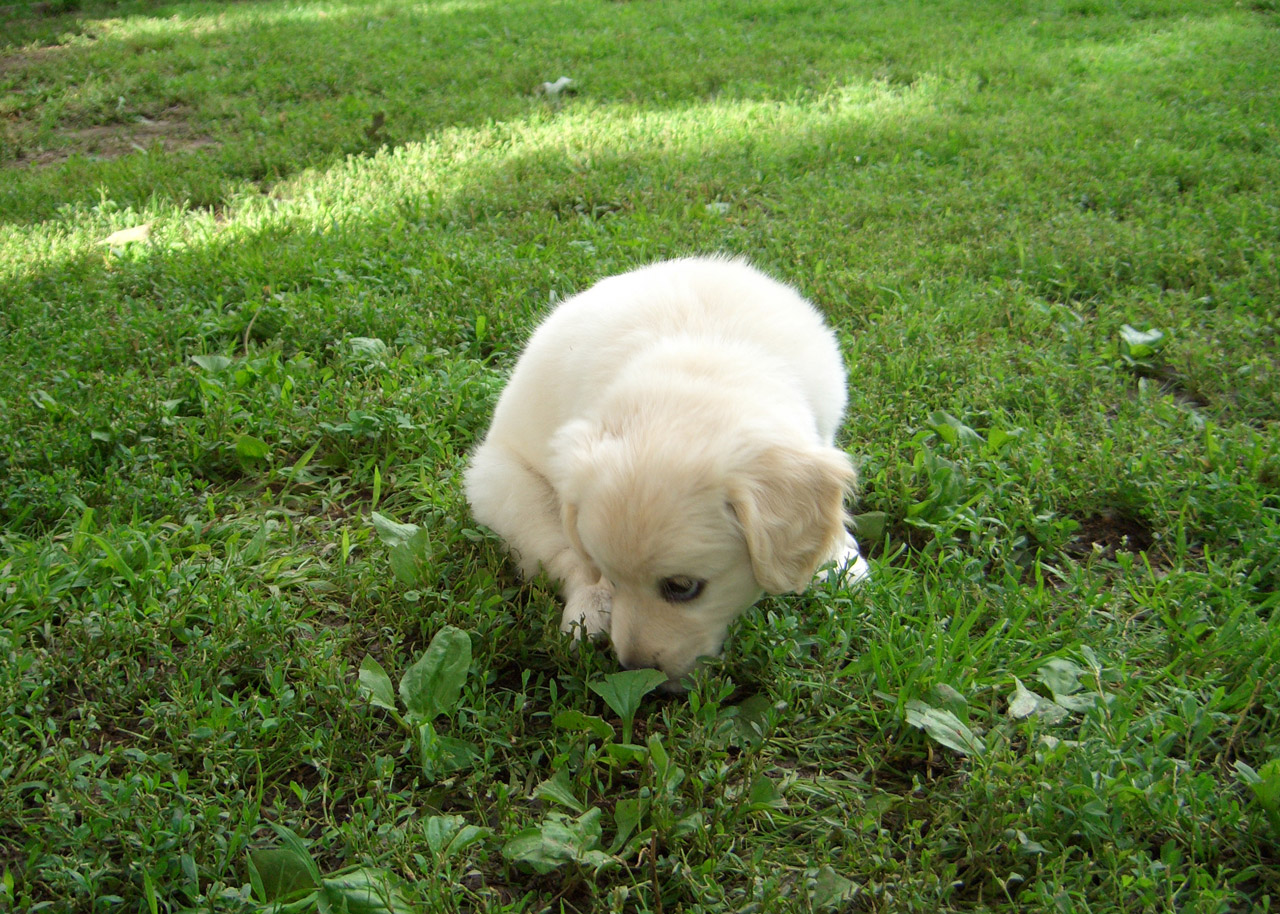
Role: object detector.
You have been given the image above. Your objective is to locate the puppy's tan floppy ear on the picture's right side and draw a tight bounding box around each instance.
[728,447,856,594]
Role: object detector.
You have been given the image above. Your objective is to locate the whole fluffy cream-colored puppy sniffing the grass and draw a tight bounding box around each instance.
[466,259,867,686]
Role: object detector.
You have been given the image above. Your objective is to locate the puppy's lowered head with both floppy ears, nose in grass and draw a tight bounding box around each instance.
[553,421,854,689]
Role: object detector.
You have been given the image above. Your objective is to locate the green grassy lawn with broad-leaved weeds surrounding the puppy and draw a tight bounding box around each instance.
[0,0,1280,913]
